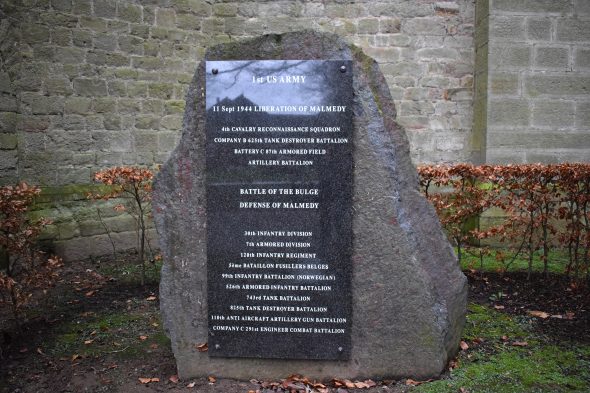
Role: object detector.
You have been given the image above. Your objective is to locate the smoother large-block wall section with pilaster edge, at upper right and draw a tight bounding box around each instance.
[474,0,590,163]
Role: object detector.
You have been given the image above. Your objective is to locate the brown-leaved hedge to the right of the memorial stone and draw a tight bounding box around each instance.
[418,163,590,282]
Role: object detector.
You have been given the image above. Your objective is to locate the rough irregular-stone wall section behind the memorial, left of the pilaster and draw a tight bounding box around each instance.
[0,0,474,258]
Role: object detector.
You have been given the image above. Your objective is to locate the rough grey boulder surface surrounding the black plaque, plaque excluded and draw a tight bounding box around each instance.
[154,31,467,379]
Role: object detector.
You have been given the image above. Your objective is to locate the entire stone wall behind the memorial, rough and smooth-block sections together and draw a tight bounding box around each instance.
[0,0,590,257]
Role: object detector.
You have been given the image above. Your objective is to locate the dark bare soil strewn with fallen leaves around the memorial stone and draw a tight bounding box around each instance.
[0,261,590,393]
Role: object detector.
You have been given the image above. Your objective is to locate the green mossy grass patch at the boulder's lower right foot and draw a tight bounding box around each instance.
[411,303,590,393]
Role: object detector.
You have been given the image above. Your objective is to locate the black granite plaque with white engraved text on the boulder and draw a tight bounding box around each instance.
[206,60,352,359]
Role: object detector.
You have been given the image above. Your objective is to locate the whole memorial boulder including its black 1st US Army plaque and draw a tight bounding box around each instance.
[154,31,467,379]
